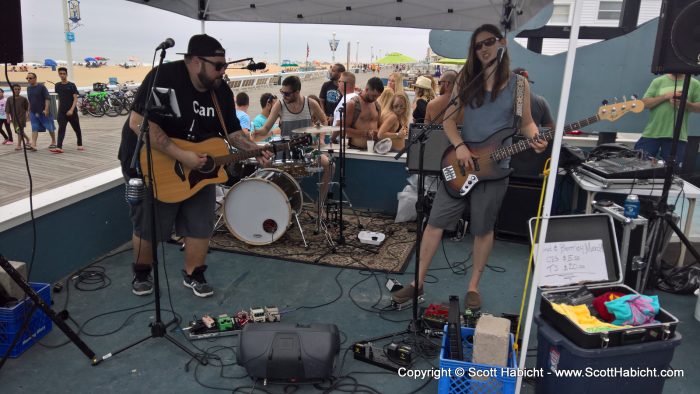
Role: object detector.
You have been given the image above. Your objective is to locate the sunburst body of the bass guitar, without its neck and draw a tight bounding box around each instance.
[441,128,515,198]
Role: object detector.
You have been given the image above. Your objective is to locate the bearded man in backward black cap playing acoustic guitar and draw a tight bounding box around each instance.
[119,34,272,297]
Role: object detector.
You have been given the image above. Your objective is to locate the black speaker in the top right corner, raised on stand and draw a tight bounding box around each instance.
[651,0,700,74]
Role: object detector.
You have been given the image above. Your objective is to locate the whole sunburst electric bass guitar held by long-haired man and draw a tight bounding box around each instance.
[441,99,644,198]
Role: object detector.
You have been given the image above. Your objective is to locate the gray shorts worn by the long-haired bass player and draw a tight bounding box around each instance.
[428,178,508,235]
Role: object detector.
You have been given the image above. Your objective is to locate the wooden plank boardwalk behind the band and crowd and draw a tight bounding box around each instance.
[0,73,385,207]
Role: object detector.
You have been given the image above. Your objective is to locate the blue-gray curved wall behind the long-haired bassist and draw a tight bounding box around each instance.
[430,16,700,135]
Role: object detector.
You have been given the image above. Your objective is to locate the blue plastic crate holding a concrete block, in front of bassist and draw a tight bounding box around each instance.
[438,326,517,394]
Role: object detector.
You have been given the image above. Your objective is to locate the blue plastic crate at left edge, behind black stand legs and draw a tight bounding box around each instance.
[0,283,52,357]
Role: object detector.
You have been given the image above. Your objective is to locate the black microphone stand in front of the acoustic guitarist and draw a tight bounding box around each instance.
[94,44,207,365]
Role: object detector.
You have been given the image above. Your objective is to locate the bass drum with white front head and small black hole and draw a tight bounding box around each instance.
[224,168,304,245]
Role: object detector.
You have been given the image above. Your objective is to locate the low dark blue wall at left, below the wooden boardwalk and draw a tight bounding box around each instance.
[0,186,131,283]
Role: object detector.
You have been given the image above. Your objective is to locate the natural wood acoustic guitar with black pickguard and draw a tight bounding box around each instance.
[140,135,311,203]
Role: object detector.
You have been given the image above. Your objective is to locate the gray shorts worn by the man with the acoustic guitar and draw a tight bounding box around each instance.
[129,185,216,241]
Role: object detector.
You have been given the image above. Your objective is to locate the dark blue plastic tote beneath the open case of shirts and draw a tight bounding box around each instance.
[534,314,681,394]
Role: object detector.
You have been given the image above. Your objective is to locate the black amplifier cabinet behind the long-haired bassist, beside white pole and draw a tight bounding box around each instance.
[495,176,542,243]
